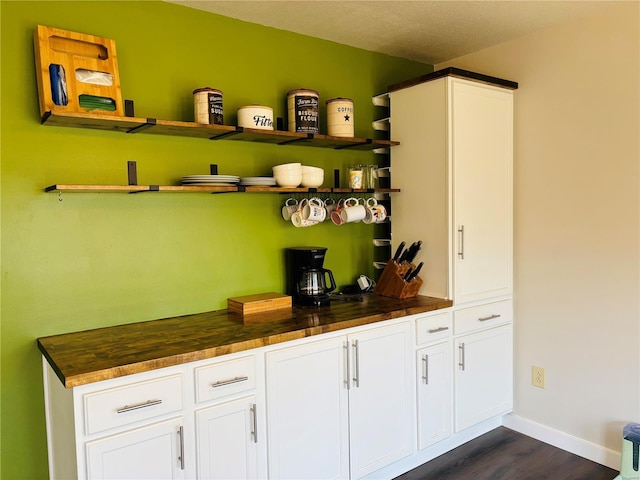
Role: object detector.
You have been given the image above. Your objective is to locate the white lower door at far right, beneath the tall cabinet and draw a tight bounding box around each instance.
[454,325,513,432]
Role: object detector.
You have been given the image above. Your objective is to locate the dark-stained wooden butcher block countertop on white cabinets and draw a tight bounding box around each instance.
[38,294,452,388]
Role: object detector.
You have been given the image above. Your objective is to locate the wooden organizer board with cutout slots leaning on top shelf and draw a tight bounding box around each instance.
[34,25,124,116]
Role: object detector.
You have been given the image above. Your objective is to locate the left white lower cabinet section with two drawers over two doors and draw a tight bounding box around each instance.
[44,352,266,480]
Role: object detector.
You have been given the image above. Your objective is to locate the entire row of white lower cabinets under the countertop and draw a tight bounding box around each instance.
[43,310,512,480]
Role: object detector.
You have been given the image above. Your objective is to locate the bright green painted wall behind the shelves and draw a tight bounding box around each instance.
[0,1,433,480]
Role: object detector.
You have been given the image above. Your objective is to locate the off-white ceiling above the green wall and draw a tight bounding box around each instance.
[167,0,620,64]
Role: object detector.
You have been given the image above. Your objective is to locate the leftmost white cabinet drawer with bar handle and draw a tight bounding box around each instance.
[84,374,183,435]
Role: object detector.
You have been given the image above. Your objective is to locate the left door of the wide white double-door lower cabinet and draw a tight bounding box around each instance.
[266,337,349,480]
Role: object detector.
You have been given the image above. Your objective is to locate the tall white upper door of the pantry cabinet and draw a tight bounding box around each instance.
[451,80,513,303]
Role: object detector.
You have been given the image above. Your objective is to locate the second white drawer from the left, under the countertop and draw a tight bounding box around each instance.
[195,356,256,403]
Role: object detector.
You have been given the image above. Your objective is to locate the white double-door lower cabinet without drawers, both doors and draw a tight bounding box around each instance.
[266,322,414,479]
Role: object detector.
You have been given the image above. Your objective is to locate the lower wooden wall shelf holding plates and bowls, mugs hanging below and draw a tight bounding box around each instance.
[44,184,400,194]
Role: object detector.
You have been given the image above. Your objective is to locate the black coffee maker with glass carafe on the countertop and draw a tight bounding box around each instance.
[286,247,336,307]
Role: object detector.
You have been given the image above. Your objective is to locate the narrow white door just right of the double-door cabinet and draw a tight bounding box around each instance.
[417,342,452,450]
